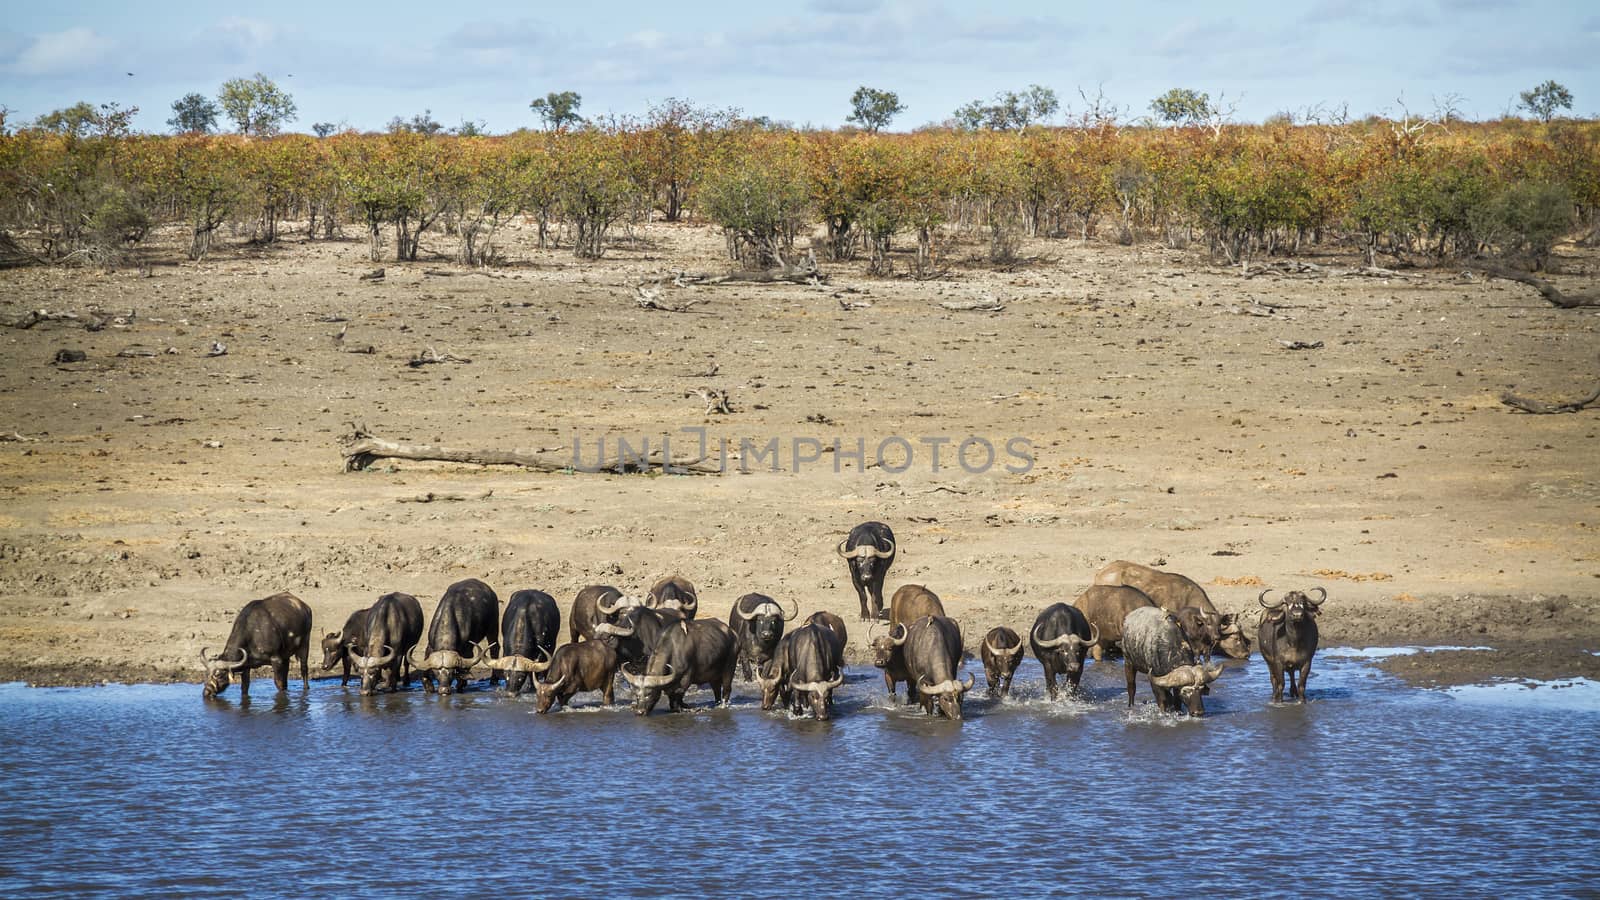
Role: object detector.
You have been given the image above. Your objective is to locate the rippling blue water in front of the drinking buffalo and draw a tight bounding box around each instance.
[0,657,1600,898]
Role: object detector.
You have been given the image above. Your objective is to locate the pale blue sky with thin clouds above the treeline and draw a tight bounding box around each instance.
[0,0,1600,133]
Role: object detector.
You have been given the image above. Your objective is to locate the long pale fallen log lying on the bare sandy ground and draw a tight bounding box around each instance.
[339,428,722,476]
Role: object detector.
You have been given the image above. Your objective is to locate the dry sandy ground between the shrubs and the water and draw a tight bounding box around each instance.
[0,224,1600,684]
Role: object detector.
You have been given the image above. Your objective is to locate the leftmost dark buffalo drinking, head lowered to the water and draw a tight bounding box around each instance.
[200,593,312,700]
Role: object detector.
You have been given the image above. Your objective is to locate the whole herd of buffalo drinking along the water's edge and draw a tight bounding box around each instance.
[200,522,1328,719]
